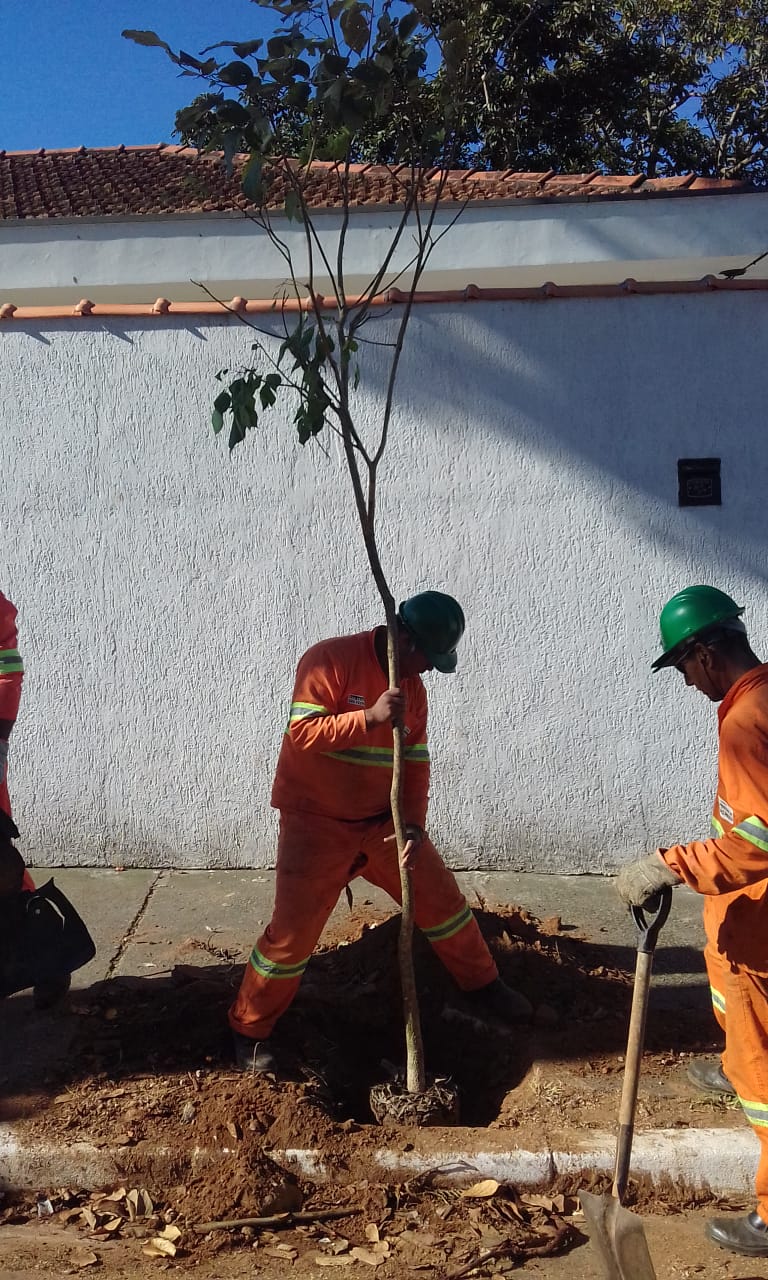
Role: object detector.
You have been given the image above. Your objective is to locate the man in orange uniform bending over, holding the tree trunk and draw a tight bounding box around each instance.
[229,591,531,1071]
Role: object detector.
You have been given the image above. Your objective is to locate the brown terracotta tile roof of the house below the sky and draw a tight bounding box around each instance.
[0,143,750,221]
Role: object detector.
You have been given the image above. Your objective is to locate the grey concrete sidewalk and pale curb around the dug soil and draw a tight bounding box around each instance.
[0,869,758,1194]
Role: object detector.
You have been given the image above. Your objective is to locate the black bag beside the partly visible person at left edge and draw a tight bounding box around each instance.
[0,879,96,998]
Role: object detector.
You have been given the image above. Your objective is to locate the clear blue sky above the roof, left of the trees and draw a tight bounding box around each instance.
[0,0,274,151]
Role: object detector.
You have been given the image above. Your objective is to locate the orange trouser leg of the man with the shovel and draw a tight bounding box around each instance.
[704,942,768,1224]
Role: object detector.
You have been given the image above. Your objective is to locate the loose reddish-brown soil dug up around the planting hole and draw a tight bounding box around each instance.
[3,908,730,1254]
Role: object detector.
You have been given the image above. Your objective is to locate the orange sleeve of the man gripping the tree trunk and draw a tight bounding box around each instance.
[287,645,366,751]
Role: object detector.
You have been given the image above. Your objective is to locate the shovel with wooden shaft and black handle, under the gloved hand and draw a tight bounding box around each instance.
[579,886,672,1280]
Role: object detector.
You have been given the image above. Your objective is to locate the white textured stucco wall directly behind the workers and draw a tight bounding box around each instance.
[0,293,768,872]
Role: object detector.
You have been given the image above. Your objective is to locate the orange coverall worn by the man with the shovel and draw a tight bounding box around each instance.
[662,664,768,1224]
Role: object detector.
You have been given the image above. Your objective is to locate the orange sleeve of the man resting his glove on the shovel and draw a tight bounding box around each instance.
[662,708,768,893]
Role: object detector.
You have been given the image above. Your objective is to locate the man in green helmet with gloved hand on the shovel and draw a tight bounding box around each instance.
[617,586,768,1257]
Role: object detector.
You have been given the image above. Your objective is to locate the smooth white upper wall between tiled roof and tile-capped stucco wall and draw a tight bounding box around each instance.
[0,192,768,306]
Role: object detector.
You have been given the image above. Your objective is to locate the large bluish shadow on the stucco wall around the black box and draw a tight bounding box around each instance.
[403,293,768,586]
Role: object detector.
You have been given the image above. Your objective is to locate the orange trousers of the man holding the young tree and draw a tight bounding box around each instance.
[229,812,498,1039]
